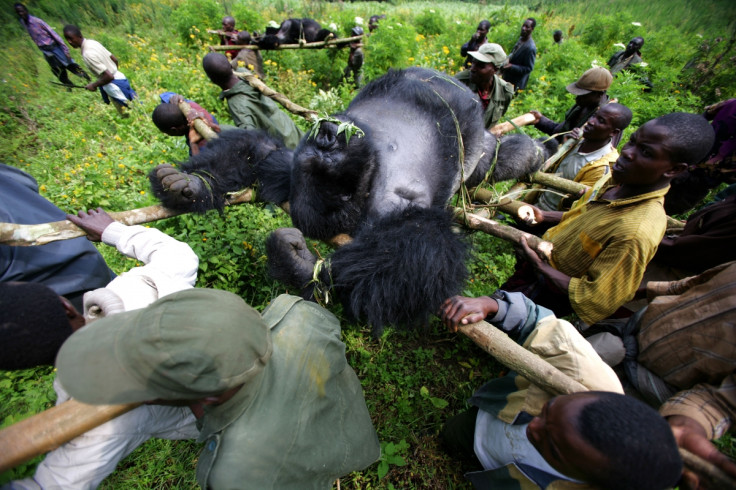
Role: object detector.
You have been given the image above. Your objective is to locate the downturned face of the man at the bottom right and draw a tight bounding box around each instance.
[526,393,609,482]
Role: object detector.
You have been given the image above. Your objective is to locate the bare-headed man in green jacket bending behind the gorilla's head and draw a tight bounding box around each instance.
[202,53,304,149]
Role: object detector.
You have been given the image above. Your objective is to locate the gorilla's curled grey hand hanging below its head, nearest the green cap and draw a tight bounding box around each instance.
[266,228,317,289]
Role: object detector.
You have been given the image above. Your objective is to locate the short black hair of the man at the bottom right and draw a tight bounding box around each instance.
[576,391,682,490]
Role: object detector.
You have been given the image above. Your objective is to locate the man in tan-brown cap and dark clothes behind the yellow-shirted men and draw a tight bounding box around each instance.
[530,66,620,146]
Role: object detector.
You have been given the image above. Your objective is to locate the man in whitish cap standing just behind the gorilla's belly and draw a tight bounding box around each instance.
[456,43,514,129]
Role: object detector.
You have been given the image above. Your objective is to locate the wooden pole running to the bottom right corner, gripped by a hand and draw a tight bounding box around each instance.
[458,322,736,488]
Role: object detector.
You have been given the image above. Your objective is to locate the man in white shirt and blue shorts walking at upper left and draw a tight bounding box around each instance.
[64,24,137,117]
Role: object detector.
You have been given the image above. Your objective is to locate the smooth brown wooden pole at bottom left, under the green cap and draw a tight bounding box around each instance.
[0,400,140,473]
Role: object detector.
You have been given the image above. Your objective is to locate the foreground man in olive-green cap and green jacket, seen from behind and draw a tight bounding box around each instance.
[57,289,380,489]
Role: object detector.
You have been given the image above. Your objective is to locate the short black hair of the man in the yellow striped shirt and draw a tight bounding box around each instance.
[654,112,716,165]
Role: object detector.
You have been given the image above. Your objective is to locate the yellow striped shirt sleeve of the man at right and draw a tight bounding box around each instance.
[568,237,656,325]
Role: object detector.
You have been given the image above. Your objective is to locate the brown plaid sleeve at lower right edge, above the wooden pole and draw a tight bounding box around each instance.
[659,374,736,439]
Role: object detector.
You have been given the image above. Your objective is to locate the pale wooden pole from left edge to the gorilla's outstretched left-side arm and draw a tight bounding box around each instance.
[0,189,254,247]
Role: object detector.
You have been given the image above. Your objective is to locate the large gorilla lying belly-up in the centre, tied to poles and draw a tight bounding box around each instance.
[149,68,554,334]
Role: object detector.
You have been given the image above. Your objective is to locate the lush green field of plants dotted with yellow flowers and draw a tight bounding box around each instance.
[0,0,736,489]
